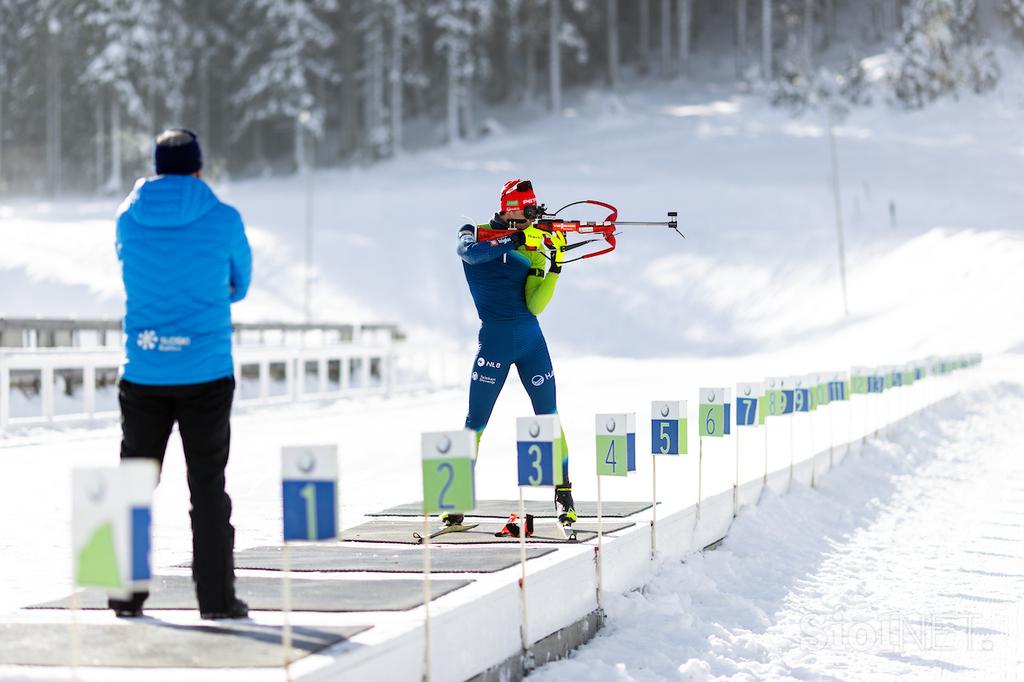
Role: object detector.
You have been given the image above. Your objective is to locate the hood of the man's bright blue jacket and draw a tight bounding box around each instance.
[122,175,219,227]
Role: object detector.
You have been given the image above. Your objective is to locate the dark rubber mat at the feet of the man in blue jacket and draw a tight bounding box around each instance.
[29,576,471,613]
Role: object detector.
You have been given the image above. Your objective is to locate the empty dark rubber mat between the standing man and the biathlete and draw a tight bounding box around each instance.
[225,544,555,573]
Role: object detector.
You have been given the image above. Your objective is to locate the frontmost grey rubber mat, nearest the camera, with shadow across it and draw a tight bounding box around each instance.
[0,619,372,668]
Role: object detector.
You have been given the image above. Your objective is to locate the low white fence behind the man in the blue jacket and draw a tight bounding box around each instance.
[0,341,455,432]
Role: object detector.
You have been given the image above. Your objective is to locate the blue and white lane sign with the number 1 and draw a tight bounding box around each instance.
[281,445,338,543]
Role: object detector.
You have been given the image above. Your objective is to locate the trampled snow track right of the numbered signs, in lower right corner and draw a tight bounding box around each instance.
[530,383,1024,681]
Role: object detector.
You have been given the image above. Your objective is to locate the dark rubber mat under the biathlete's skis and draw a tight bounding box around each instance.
[341,519,634,545]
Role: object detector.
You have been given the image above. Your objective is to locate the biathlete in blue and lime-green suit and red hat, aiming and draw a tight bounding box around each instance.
[444,180,577,525]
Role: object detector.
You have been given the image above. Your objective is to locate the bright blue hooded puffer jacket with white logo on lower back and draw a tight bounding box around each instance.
[117,175,252,386]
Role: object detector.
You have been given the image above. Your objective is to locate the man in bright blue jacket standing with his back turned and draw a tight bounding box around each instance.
[110,129,252,619]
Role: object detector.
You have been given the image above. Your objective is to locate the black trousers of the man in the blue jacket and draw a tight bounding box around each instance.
[110,377,234,612]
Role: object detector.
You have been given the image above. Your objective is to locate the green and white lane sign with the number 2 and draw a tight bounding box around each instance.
[422,429,476,514]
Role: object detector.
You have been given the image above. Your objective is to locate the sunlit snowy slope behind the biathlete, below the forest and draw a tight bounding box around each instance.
[0,63,1024,356]
